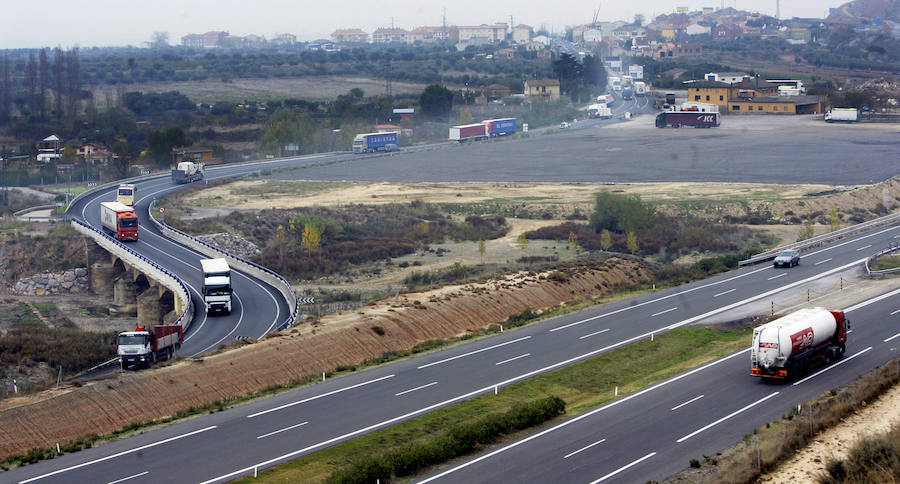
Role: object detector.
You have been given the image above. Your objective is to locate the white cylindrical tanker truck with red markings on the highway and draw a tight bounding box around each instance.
[750,308,850,379]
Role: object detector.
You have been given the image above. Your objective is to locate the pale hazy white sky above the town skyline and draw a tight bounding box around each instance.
[0,0,846,49]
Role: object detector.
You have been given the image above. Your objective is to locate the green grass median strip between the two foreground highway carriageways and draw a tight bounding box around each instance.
[238,326,751,483]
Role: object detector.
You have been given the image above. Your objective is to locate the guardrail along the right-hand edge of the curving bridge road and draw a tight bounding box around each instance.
[148,200,300,331]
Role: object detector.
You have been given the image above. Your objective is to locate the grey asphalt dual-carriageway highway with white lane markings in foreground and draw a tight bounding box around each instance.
[8,218,900,482]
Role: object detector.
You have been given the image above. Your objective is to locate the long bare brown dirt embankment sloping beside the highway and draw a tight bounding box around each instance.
[0,258,651,458]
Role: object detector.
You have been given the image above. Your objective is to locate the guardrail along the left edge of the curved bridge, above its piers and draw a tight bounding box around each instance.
[71,217,194,331]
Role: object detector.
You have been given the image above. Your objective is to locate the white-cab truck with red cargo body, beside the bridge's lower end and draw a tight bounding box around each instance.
[117,324,184,370]
